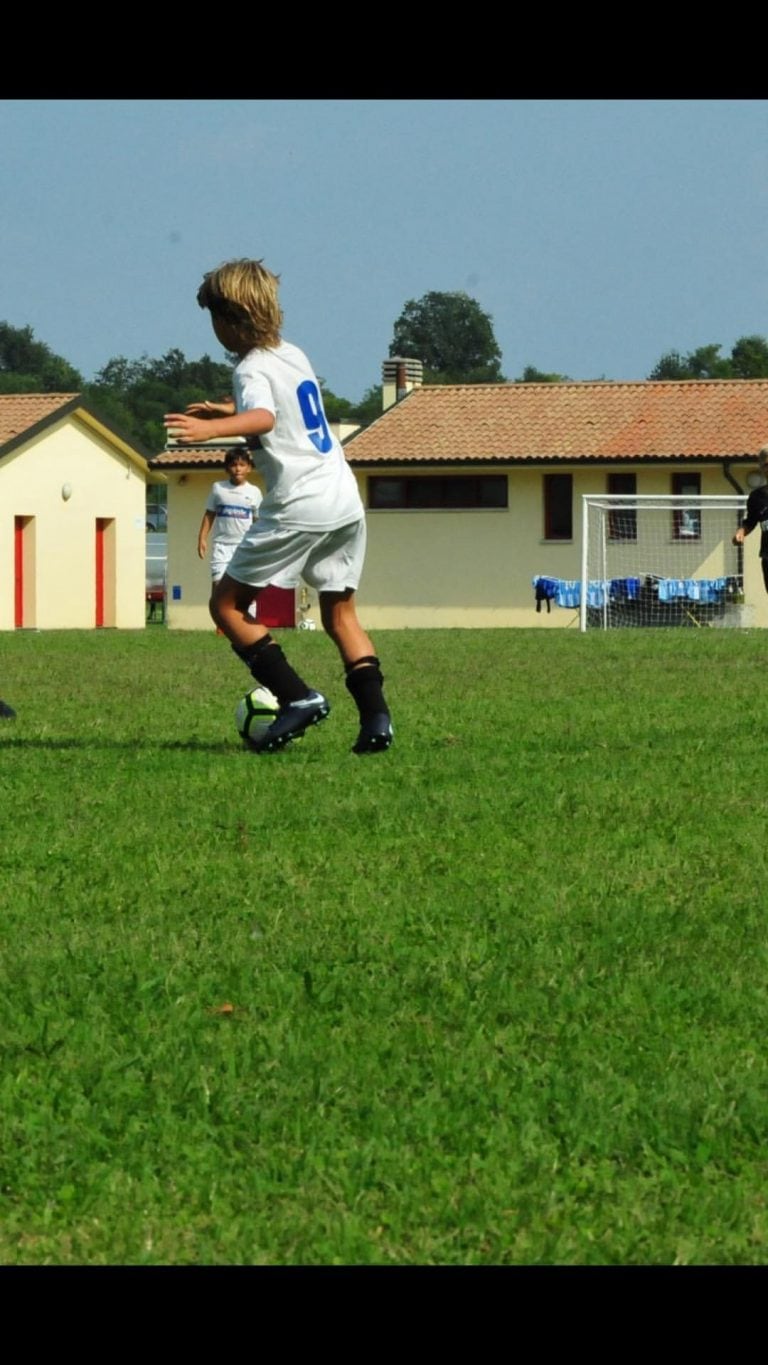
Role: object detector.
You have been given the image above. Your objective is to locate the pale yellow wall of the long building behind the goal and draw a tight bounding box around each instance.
[168,464,768,631]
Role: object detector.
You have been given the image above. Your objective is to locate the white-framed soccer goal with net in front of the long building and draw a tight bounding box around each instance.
[580,493,746,631]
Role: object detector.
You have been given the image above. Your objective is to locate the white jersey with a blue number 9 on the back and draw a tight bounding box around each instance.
[233,341,364,531]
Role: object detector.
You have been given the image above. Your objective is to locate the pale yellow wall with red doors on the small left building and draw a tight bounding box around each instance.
[0,416,146,631]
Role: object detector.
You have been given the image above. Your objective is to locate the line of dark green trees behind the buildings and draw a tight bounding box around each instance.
[0,291,768,452]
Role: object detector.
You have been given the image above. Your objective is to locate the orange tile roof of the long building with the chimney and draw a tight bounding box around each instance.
[344,379,768,464]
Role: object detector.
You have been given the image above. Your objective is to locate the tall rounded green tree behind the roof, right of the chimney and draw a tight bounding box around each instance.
[389,291,505,384]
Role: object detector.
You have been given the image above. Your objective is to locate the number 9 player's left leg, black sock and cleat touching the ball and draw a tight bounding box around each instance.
[210,573,330,752]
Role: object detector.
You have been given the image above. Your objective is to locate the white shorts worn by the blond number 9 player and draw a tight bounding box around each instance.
[226,517,366,592]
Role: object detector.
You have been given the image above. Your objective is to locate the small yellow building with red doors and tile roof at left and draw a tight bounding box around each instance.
[0,393,165,631]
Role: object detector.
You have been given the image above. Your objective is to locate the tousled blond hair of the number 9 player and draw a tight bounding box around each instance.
[198,259,282,349]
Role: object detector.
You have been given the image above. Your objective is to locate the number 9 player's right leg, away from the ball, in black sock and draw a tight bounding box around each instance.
[318,588,393,753]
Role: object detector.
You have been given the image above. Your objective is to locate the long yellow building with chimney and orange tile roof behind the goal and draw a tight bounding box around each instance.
[151,374,768,631]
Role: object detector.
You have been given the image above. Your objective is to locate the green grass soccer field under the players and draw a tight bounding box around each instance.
[0,627,768,1265]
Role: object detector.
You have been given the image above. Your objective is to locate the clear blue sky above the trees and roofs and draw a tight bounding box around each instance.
[0,100,768,400]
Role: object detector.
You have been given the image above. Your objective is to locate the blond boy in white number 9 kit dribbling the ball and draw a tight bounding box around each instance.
[165,251,393,753]
